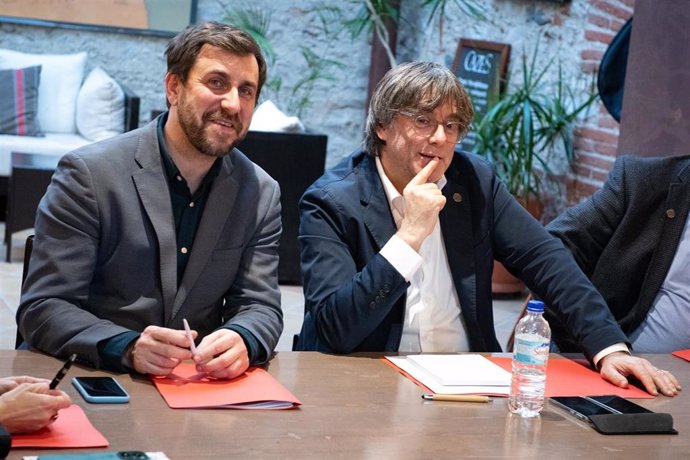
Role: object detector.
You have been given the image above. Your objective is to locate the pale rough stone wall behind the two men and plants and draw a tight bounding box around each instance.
[0,0,593,166]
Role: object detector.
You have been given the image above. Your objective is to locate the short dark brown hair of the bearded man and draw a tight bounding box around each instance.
[165,21,266,101]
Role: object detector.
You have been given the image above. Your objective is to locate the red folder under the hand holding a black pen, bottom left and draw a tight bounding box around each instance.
[12,404,108,449]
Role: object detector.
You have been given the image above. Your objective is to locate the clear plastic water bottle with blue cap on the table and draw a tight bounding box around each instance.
[508,300,551,417]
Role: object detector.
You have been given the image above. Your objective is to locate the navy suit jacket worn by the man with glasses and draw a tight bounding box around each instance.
[297,152,626,359]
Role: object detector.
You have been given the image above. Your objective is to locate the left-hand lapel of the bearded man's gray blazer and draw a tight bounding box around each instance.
[132,129,177,324]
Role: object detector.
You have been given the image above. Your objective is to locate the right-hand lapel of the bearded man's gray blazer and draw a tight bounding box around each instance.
[170,153,239,319]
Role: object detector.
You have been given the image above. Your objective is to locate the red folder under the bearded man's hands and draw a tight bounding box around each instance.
[153,363,302,409]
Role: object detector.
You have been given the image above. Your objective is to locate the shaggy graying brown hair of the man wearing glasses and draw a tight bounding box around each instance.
[364,62,474,155]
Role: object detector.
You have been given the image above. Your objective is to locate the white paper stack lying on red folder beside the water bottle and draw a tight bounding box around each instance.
[386,354,510,396]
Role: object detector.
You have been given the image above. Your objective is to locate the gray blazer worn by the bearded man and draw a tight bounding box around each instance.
[17,121,283,367]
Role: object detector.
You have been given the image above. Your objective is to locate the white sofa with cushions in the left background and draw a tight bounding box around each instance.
[0,49,140,216]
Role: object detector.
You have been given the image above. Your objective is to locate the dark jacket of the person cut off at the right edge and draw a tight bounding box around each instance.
[547,156,690,351]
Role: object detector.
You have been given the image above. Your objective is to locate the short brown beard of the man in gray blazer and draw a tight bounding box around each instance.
[178,93,243,158]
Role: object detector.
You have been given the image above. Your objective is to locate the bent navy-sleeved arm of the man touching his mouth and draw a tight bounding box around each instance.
[299,185,409,353]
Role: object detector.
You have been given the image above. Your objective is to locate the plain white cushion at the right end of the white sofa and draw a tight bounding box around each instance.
[77,67,125,141]
